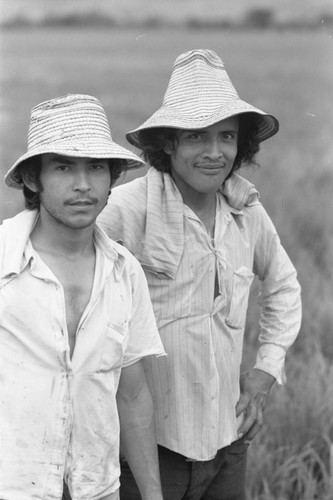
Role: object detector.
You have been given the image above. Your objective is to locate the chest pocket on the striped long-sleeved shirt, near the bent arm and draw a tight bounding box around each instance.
[226,266,254,328]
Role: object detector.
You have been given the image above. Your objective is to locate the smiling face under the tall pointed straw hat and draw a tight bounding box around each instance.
[165,116,239,202]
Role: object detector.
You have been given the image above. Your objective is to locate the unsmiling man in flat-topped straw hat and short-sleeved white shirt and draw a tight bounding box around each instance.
[0,94,165,500]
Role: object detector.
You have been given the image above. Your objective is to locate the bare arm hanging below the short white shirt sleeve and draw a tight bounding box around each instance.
[117,361,163,500]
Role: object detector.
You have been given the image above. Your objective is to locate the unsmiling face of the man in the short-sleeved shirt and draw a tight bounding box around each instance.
[36,153,111,229]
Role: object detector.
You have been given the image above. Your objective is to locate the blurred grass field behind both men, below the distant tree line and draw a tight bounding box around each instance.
[0,28,333,500]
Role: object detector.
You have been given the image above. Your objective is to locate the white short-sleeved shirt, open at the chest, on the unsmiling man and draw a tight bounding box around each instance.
[0,211,164,500]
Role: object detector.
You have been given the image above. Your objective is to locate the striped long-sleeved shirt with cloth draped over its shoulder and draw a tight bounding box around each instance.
[99,169,301,460]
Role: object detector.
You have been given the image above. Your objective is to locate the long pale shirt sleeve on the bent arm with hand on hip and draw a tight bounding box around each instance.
[255,208,302,384]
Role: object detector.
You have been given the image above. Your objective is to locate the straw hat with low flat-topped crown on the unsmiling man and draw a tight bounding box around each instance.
[5,94,143,189]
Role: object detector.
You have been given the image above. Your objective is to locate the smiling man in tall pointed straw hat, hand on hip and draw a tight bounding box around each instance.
[99,50,301,500]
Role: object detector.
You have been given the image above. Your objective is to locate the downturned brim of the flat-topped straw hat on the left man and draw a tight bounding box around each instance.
[4,141,145,189]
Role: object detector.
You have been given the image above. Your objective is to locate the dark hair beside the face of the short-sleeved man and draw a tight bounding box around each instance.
[18,155,127,210]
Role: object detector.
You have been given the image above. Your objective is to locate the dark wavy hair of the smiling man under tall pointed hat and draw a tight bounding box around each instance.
[138,113,260,173]
